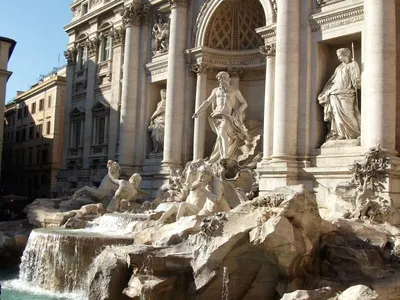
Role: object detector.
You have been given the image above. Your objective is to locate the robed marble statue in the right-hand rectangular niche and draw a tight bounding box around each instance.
[318,48,361,141]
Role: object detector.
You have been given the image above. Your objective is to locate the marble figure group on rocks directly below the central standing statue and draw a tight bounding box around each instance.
[157,163,230,226]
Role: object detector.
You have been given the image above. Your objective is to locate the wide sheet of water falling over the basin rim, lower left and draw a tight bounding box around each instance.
[19,228,133,292]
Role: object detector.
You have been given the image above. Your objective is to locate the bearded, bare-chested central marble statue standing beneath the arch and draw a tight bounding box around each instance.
[193,71,261,164]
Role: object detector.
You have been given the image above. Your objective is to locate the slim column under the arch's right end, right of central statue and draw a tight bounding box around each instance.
[260,44,275,161]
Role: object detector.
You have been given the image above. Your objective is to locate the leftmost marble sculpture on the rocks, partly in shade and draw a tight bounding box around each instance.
[71,160,121,206]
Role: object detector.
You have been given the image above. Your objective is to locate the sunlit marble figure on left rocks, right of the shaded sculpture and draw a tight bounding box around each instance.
[107,173,142,211]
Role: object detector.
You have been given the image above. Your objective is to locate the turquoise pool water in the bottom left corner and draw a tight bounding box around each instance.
[0,269,87,300]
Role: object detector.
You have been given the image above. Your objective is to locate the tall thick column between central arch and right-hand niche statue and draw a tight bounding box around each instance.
[272,0,300,161]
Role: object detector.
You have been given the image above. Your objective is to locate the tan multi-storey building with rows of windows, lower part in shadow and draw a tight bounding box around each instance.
[2,68,66,199]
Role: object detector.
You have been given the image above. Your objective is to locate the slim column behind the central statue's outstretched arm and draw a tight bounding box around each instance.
[192,65,209,160]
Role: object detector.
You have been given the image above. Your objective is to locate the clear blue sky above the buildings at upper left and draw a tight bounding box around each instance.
[0,0,72,102]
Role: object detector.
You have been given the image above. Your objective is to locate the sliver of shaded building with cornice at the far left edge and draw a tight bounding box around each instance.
[0,36,16,179]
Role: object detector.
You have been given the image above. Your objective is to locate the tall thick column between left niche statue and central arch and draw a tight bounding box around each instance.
[163,0,187,168]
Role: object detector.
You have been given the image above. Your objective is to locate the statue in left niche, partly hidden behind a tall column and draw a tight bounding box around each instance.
[148,89,167,153]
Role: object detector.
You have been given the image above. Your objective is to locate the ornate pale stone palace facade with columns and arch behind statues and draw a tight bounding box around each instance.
[58,0,400,206]
